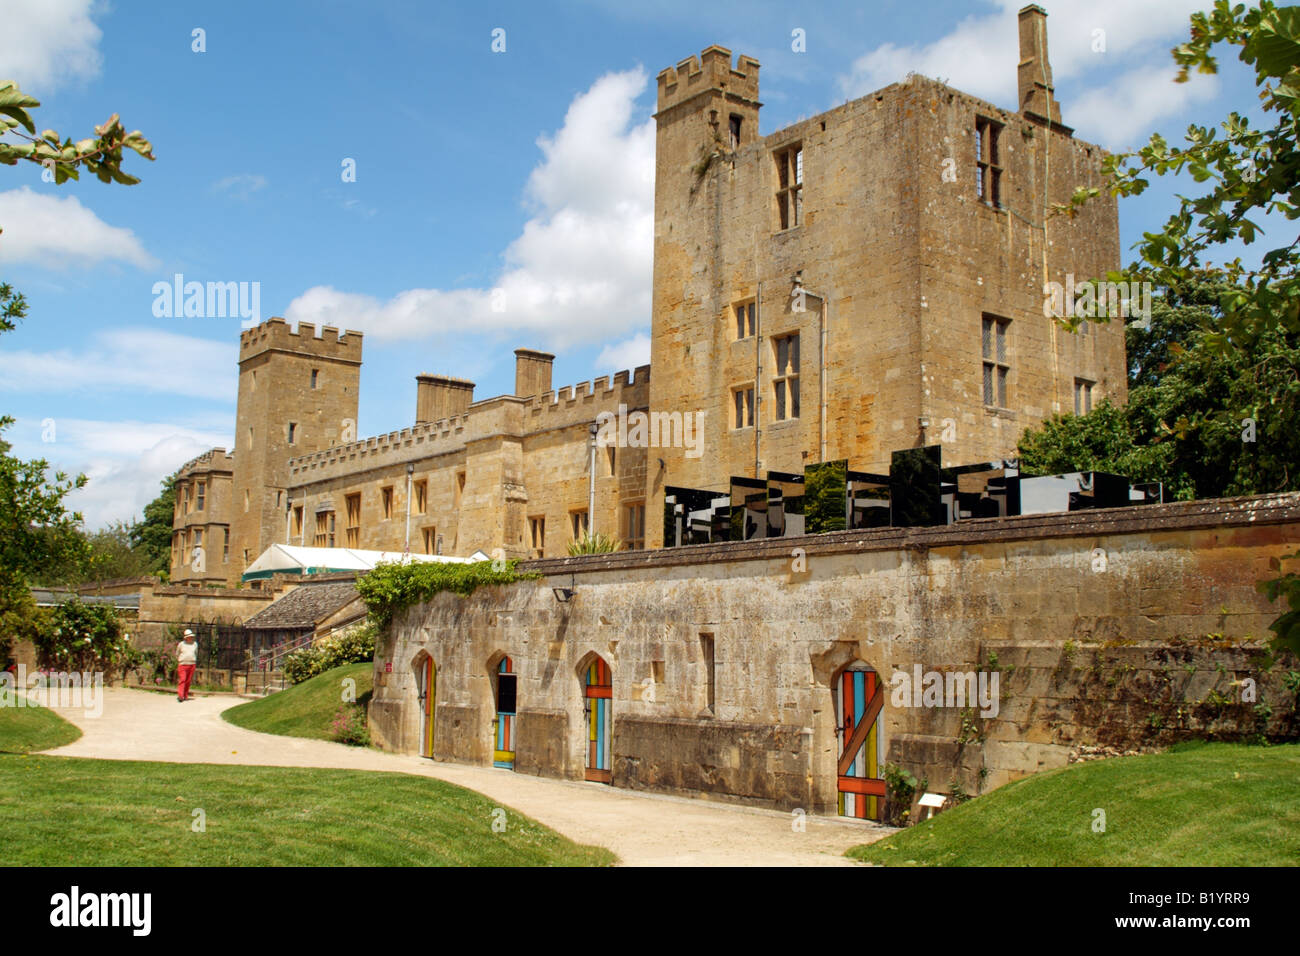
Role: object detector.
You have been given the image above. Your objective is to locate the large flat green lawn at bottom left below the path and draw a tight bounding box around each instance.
[0,756,614,866]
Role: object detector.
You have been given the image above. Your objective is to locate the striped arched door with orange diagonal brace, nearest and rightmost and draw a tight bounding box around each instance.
[836,665,885,819]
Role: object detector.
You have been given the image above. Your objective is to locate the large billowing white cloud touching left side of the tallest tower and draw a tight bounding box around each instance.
[285,69,654,349]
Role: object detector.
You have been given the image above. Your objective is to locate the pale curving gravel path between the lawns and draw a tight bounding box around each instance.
[47,688,892,866]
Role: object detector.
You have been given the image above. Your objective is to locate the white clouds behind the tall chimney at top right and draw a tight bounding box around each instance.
[839,0,1205,139]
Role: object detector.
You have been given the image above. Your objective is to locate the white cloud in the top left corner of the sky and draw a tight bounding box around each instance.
[0,0,101,91]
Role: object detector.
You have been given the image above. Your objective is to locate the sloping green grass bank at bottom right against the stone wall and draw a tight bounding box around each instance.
[849,744,1300,866]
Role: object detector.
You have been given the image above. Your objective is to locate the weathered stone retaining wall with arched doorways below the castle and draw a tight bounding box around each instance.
[371,494,1300,812]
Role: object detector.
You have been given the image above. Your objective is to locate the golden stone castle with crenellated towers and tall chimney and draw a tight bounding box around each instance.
[172,7,1126,584]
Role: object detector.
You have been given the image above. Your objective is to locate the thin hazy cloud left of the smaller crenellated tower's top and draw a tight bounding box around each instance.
[0,328,237,402]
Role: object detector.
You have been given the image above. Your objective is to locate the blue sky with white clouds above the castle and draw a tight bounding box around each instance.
[0,0,1256,527]
